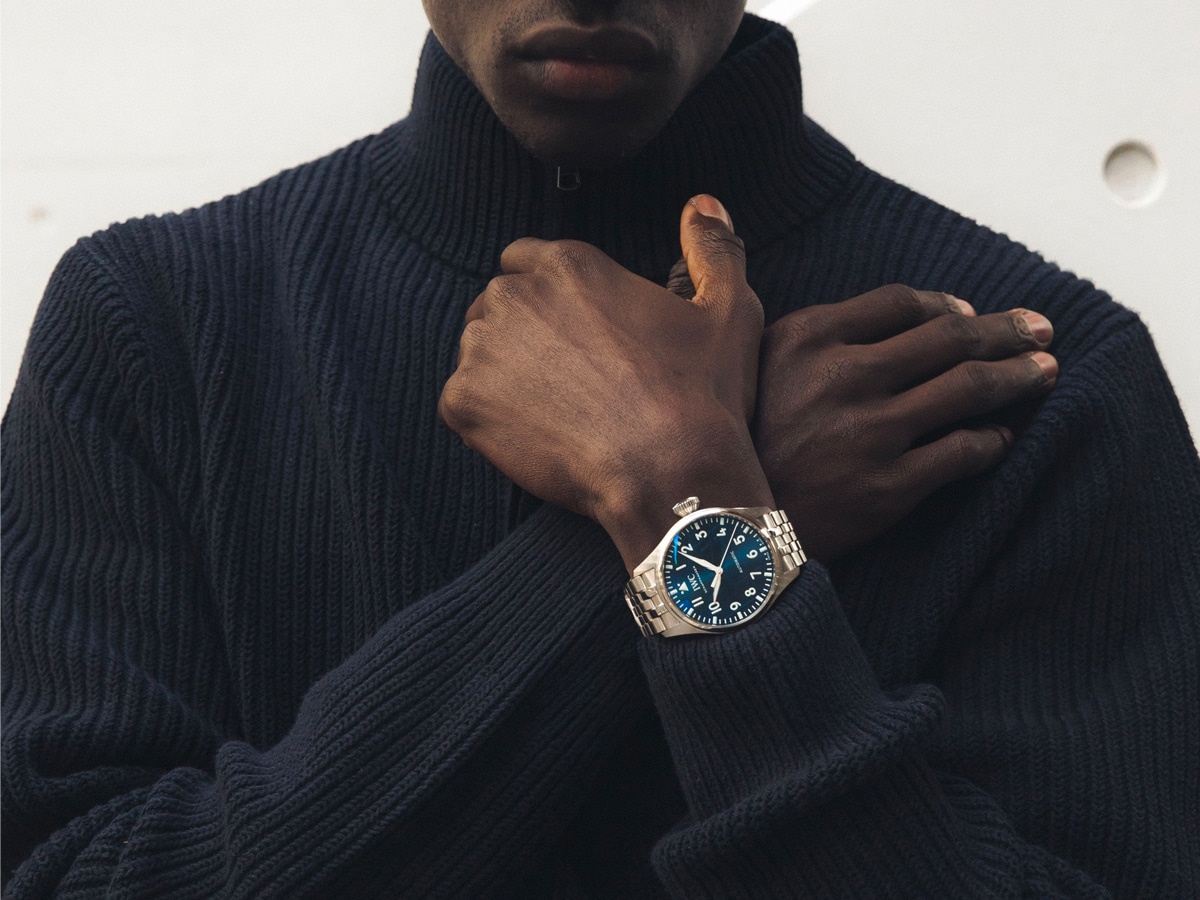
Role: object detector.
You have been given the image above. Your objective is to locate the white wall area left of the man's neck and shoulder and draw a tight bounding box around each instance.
[0,0,427,404]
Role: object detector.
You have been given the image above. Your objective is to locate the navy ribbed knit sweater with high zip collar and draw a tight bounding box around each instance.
[2,17,1200,898]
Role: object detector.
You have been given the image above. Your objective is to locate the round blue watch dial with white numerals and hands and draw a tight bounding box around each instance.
[662,512,775,626]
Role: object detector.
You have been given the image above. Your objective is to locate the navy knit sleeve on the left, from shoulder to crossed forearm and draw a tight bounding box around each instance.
[2,247,641,898]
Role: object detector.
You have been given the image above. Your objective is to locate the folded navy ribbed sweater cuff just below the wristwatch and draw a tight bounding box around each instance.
[641,563,942,820]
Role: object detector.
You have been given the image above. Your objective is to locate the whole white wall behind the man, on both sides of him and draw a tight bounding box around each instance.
[0,0,1200,422]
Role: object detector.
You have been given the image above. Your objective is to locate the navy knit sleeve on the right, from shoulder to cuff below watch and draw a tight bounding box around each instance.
[641,320,1200,898]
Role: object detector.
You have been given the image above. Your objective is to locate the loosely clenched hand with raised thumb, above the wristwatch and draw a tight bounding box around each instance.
[439,194,774,568]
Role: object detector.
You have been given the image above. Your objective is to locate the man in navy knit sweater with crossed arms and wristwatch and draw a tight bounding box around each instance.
[4,0,1200,898]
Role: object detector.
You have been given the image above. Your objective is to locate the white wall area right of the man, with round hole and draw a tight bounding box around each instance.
[750,0,1200,437]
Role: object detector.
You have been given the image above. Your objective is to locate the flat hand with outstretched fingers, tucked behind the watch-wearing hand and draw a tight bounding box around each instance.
[754,286,1058,562]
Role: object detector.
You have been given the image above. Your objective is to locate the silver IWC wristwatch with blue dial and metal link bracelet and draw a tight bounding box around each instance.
[625,497,805,637]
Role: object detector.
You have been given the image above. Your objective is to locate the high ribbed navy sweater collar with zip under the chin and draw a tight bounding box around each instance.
[368,14,854,280]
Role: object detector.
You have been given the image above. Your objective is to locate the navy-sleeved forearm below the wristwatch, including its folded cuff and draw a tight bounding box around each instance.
[642,564,1105,898]
